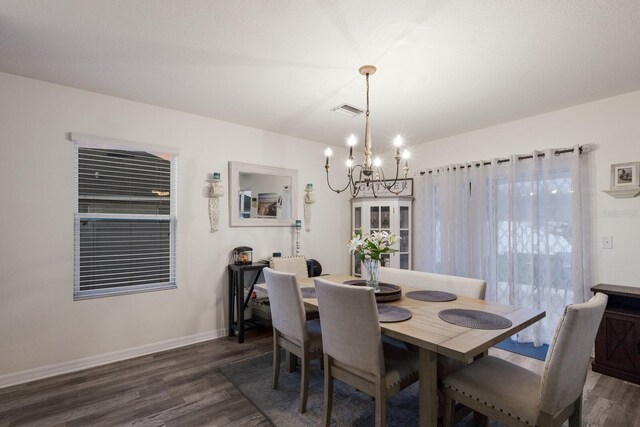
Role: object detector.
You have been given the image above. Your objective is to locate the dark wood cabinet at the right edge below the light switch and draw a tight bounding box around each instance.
[591,284,640,384]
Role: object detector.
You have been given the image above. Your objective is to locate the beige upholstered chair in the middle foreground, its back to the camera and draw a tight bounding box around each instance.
[314,278,418,426]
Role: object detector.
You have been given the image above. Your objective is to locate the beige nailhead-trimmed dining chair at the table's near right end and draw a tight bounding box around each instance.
[442,293,607,427]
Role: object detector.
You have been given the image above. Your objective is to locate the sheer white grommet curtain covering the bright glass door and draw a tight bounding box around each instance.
[415,147,591,345]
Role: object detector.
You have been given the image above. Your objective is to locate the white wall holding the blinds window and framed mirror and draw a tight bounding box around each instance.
[0,73,350,385]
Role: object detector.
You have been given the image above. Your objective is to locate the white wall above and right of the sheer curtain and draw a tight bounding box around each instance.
[411,92,640,287]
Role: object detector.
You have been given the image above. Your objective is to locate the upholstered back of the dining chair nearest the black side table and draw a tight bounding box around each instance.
[262,267,309,346]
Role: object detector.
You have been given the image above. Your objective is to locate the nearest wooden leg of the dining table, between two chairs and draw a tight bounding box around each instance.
[418,347,438,427]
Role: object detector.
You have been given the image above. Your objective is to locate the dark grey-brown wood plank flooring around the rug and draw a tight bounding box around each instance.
[0,331,640,427]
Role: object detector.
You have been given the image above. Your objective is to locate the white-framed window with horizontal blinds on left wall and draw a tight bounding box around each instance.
[72,135,177,299]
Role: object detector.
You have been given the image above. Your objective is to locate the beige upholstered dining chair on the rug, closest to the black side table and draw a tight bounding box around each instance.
[262,267,322,412]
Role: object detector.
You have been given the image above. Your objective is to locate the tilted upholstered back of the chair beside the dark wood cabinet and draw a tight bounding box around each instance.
[539,293,608,414]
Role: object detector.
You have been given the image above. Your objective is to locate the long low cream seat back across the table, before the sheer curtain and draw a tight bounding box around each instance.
[378,267,487,299]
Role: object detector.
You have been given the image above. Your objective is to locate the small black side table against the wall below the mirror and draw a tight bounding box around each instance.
[229,263,269,343]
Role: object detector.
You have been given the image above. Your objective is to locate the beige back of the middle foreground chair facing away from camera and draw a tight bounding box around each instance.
[314,278,385,375]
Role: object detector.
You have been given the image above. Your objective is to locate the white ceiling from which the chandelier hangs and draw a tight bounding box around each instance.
[0,0,640,148]
